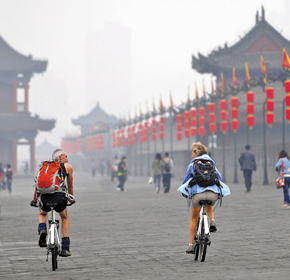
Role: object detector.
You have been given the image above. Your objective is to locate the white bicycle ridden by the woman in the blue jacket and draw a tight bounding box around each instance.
[194,200,212,262]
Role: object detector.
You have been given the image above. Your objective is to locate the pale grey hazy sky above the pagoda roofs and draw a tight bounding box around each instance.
[0,0,290,149]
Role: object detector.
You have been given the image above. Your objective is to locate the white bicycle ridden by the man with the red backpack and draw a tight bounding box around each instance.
[33,194,75,271]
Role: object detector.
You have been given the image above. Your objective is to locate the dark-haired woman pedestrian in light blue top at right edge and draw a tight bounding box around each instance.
[275,150,290,209]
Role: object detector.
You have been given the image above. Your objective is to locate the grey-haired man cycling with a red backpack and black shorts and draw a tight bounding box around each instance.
[30,149,73,257]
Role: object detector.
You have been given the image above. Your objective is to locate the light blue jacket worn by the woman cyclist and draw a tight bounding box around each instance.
[177,154,231,198]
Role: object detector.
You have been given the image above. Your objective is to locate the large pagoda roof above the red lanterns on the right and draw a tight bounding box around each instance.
[192,10,290,75]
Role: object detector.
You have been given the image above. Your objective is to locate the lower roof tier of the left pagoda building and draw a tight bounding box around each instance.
[0,113,55,132]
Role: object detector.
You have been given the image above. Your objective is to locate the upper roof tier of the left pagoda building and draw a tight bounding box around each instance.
[0,37,47,73]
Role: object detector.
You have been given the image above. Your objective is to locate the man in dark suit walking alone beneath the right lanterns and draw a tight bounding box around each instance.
[239,145,256,192]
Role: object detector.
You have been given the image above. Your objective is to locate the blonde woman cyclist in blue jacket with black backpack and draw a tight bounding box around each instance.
[178,142,230,254]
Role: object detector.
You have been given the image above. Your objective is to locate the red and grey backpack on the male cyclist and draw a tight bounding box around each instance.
[35,161,65,194]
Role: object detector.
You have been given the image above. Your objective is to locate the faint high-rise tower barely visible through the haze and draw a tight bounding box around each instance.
[86,23,132,115]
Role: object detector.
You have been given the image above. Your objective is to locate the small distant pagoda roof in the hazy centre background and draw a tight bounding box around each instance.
[72,103,118,127]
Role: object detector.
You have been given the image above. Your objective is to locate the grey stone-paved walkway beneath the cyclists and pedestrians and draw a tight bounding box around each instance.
[0,173,290,280]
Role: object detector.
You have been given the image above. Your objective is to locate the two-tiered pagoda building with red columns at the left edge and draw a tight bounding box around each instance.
[0,37,55,172]
